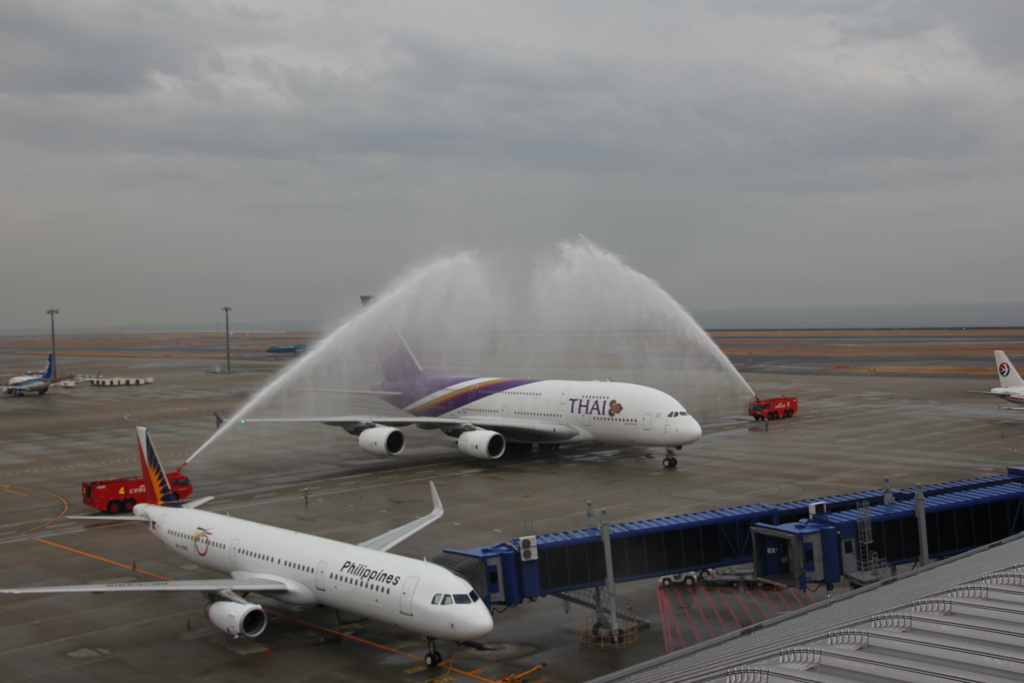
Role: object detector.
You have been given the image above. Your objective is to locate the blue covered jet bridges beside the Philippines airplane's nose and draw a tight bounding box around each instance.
[435,467,1024,605]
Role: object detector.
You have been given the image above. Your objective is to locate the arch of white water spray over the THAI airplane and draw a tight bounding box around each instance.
[189,238,753,460]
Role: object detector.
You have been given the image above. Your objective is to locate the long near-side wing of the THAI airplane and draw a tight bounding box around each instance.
[242,415,580,442]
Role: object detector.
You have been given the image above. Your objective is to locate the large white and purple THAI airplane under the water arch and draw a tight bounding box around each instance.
[242,323,700,467]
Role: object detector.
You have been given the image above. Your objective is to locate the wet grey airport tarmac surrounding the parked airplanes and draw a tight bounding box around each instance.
[0,330,1024,683]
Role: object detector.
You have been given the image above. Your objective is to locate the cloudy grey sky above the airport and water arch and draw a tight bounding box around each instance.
[0,0,1024,331]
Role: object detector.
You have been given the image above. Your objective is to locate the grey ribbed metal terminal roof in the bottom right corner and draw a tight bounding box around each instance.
[591,535,1024,683]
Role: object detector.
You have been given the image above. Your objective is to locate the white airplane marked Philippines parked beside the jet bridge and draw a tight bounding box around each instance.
[0,427,494,667]
